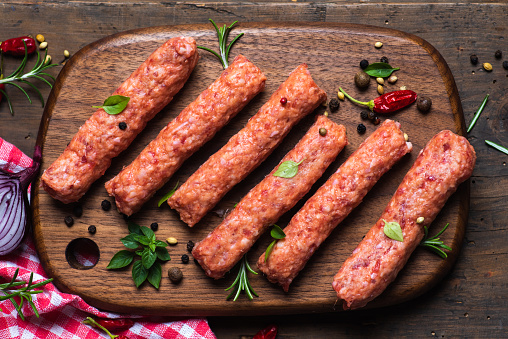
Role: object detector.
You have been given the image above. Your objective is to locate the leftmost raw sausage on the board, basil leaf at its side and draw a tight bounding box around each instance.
[41,37,198,203]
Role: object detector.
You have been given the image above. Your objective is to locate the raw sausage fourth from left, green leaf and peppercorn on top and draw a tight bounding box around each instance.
[192,116,347,279]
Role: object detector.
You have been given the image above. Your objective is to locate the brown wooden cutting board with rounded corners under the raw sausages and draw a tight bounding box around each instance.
[33,23,469,315]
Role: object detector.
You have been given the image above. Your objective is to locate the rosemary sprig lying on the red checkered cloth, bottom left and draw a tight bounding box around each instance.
[0,268,53,320]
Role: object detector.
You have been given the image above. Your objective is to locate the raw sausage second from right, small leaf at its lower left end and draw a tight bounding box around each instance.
[258,120,412,292]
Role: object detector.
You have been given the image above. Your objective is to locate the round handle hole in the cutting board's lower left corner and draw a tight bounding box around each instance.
[65,238,100,270]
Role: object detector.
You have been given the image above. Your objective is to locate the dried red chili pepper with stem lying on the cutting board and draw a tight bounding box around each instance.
[339,88,418,114]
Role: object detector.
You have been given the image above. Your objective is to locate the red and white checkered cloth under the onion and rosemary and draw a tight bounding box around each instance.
[0,138,215,339]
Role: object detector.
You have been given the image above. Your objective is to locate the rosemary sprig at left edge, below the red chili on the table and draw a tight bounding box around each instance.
[0,42,58,115]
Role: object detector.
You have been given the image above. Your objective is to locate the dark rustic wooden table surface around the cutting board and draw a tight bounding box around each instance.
[0,0,508,338]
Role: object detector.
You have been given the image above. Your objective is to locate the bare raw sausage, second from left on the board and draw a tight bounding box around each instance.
[106,55,266,215]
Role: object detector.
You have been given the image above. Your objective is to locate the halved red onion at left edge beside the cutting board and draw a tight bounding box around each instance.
[0,146,42,255]
